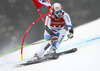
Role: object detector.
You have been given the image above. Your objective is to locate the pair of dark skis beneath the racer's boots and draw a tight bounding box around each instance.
[19,48,77,66]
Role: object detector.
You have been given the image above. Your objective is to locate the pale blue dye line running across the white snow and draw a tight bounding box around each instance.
[0,37,100,67]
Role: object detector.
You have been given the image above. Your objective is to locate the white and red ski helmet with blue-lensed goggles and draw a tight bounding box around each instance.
[51,3,63,15]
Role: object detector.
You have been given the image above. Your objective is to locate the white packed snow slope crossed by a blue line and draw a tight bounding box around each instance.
[0,18,100,71]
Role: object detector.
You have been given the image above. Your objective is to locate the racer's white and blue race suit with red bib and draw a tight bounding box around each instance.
[37,11,72,56]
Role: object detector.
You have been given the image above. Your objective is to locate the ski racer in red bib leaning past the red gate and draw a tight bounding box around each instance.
[31,3,73,61]
